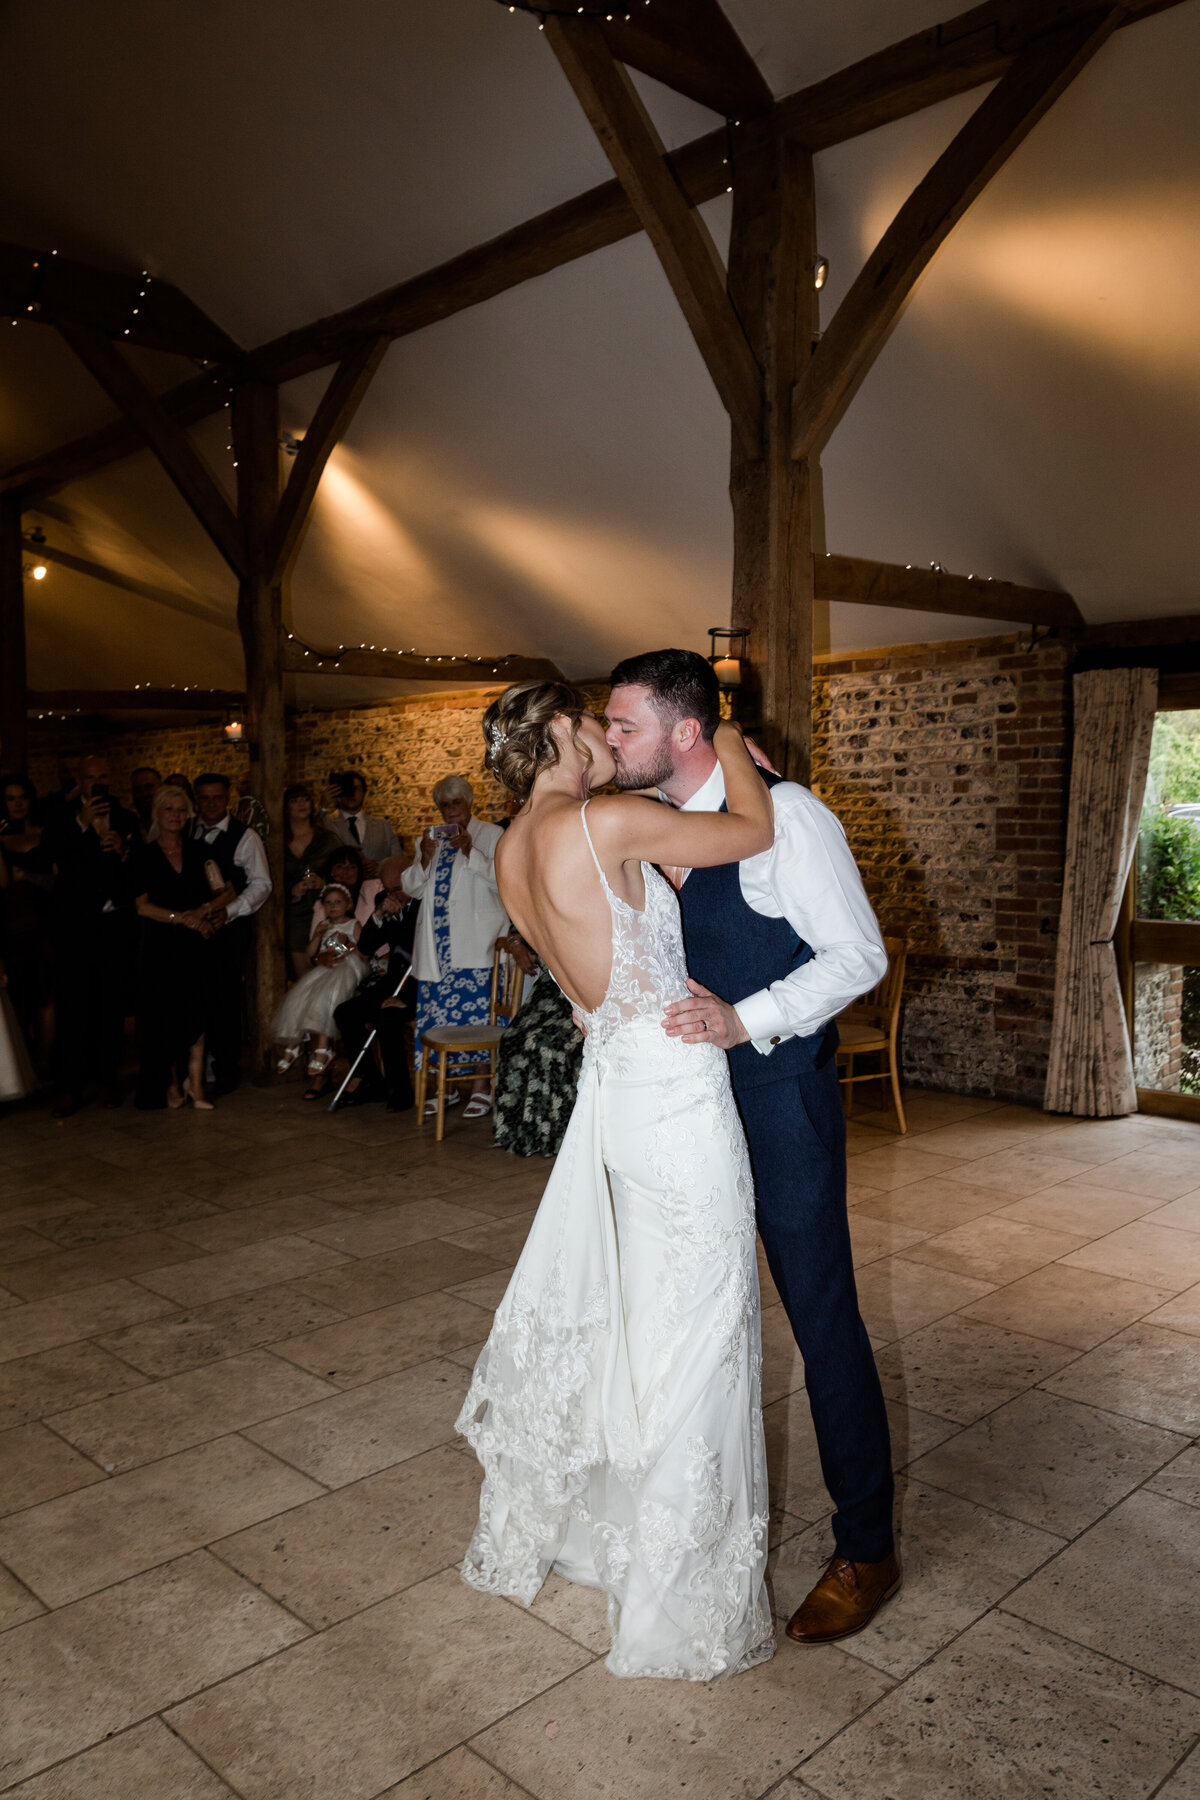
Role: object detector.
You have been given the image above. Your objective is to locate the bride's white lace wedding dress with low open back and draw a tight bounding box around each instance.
[457,806,775,1681]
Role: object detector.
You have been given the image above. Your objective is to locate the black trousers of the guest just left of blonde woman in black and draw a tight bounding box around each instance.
[54,913,133,1096]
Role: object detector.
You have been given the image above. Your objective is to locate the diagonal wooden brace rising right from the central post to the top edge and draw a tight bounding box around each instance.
[792,5,1121,457]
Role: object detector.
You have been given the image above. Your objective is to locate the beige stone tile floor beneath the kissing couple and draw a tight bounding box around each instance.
[0,1089,1200,1800]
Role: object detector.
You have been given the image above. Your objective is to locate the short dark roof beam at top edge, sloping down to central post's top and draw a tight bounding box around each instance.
[601,0,775,119]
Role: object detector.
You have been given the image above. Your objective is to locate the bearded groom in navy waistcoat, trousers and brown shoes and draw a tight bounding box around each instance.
[606,650,900,1643]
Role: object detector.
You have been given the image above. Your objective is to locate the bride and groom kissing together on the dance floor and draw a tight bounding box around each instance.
[457,650,900,1681]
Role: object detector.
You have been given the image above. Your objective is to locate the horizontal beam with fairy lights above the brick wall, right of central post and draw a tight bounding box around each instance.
[813,554,1085,626]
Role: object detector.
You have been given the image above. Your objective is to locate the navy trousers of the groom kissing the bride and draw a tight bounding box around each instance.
[738,1057,894,1562]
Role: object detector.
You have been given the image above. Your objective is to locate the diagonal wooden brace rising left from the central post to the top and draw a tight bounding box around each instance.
[545,16,763,455]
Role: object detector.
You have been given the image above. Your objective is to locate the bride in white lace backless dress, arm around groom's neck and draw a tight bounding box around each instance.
[457,682,774,1681]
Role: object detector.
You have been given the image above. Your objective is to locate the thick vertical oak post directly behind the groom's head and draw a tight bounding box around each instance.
[729,122,824,781]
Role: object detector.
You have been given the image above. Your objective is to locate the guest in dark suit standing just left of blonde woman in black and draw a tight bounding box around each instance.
[43,756,137,1118]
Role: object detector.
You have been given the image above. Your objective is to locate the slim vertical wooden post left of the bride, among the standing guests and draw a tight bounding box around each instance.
[234,382,286,1075]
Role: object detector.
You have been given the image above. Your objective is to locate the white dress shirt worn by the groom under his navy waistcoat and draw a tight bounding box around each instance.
[680,763,887,1057]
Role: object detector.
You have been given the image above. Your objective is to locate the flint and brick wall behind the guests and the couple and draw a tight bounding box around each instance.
[32,635,1069,1105]
